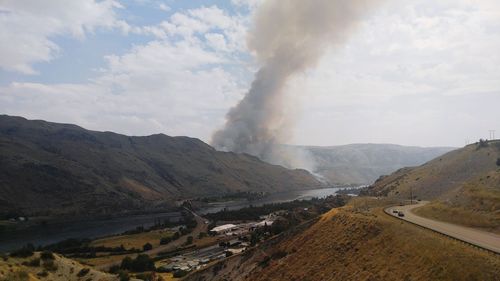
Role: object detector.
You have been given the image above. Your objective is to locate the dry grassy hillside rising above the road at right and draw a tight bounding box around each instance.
[368,141,500,233]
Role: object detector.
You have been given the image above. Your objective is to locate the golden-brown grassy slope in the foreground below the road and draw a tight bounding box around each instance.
[187,199,500,281]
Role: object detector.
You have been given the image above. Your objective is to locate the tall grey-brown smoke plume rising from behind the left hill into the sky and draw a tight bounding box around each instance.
[212,0,378,168]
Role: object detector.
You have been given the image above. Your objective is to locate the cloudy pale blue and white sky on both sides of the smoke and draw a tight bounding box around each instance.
[0,0,500,146]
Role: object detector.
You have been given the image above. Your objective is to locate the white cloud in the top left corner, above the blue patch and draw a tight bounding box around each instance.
[0,0,128,74]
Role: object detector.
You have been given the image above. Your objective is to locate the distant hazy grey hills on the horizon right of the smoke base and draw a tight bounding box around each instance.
[282,144,454,185]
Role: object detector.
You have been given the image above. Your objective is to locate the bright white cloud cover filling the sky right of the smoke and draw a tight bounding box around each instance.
[290,0,500,145]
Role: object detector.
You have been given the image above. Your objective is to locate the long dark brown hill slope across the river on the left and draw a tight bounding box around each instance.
[0,115,320,215]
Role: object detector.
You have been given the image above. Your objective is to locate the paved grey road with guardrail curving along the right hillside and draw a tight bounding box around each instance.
[384,201,500,254]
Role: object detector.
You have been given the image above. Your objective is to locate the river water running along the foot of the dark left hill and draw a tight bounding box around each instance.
[0,188,341,252]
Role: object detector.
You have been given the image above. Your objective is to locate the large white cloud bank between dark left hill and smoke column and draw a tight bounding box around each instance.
[0,4,248,140]
